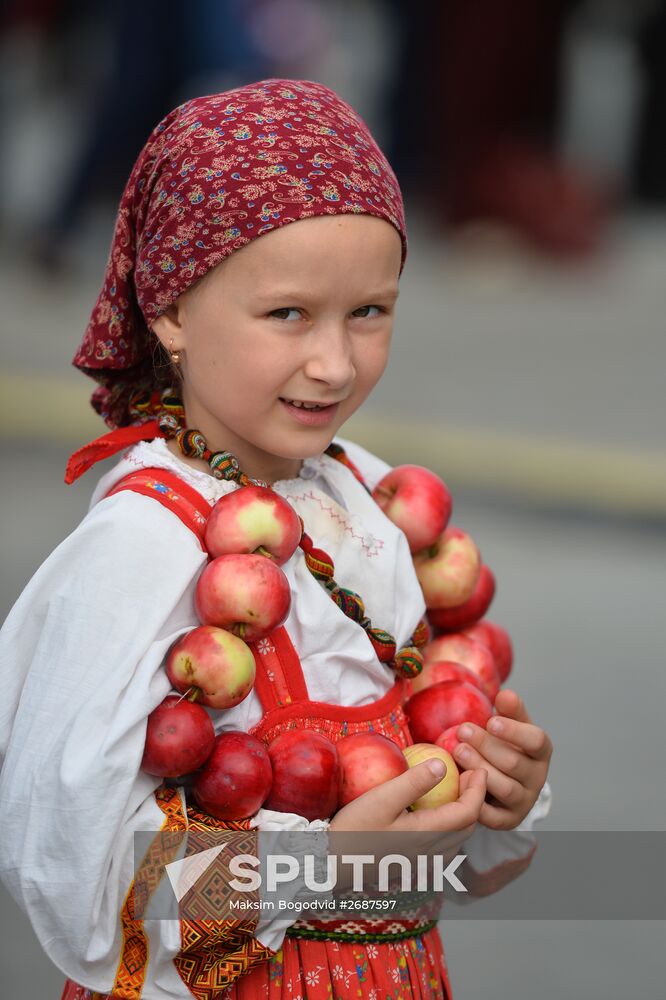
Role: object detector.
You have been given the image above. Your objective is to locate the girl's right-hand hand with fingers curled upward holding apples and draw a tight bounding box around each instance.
[454,689,553,830]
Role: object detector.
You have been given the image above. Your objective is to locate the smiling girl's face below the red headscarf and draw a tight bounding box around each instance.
[154,215,401,482]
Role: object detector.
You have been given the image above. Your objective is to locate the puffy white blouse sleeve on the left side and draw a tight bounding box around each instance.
[0,492,256,998]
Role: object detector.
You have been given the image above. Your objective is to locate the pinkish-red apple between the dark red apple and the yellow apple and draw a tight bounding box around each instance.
[335,733,407,808]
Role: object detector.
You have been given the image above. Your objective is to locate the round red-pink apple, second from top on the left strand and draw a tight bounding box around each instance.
[195,554,291,642]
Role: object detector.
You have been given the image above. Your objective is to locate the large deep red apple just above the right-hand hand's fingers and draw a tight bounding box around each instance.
[405,681,493,743]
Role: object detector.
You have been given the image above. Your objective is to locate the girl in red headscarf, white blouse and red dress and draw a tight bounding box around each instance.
[0,80,550,1000]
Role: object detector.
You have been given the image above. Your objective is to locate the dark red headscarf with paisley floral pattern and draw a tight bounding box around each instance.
[73,80,407,428]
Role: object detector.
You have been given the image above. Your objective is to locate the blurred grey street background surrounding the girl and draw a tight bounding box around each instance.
[0,0,666,1000]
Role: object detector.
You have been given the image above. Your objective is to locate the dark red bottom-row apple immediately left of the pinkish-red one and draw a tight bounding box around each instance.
[265,729,341,820]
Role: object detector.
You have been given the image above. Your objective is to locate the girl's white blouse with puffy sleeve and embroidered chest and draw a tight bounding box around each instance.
[0,439,547,998]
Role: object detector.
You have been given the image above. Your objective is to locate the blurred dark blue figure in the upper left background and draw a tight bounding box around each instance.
[5,0,272,270]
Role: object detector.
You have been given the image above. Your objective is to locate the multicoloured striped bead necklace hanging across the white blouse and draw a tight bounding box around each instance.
[131,389,429,677]
